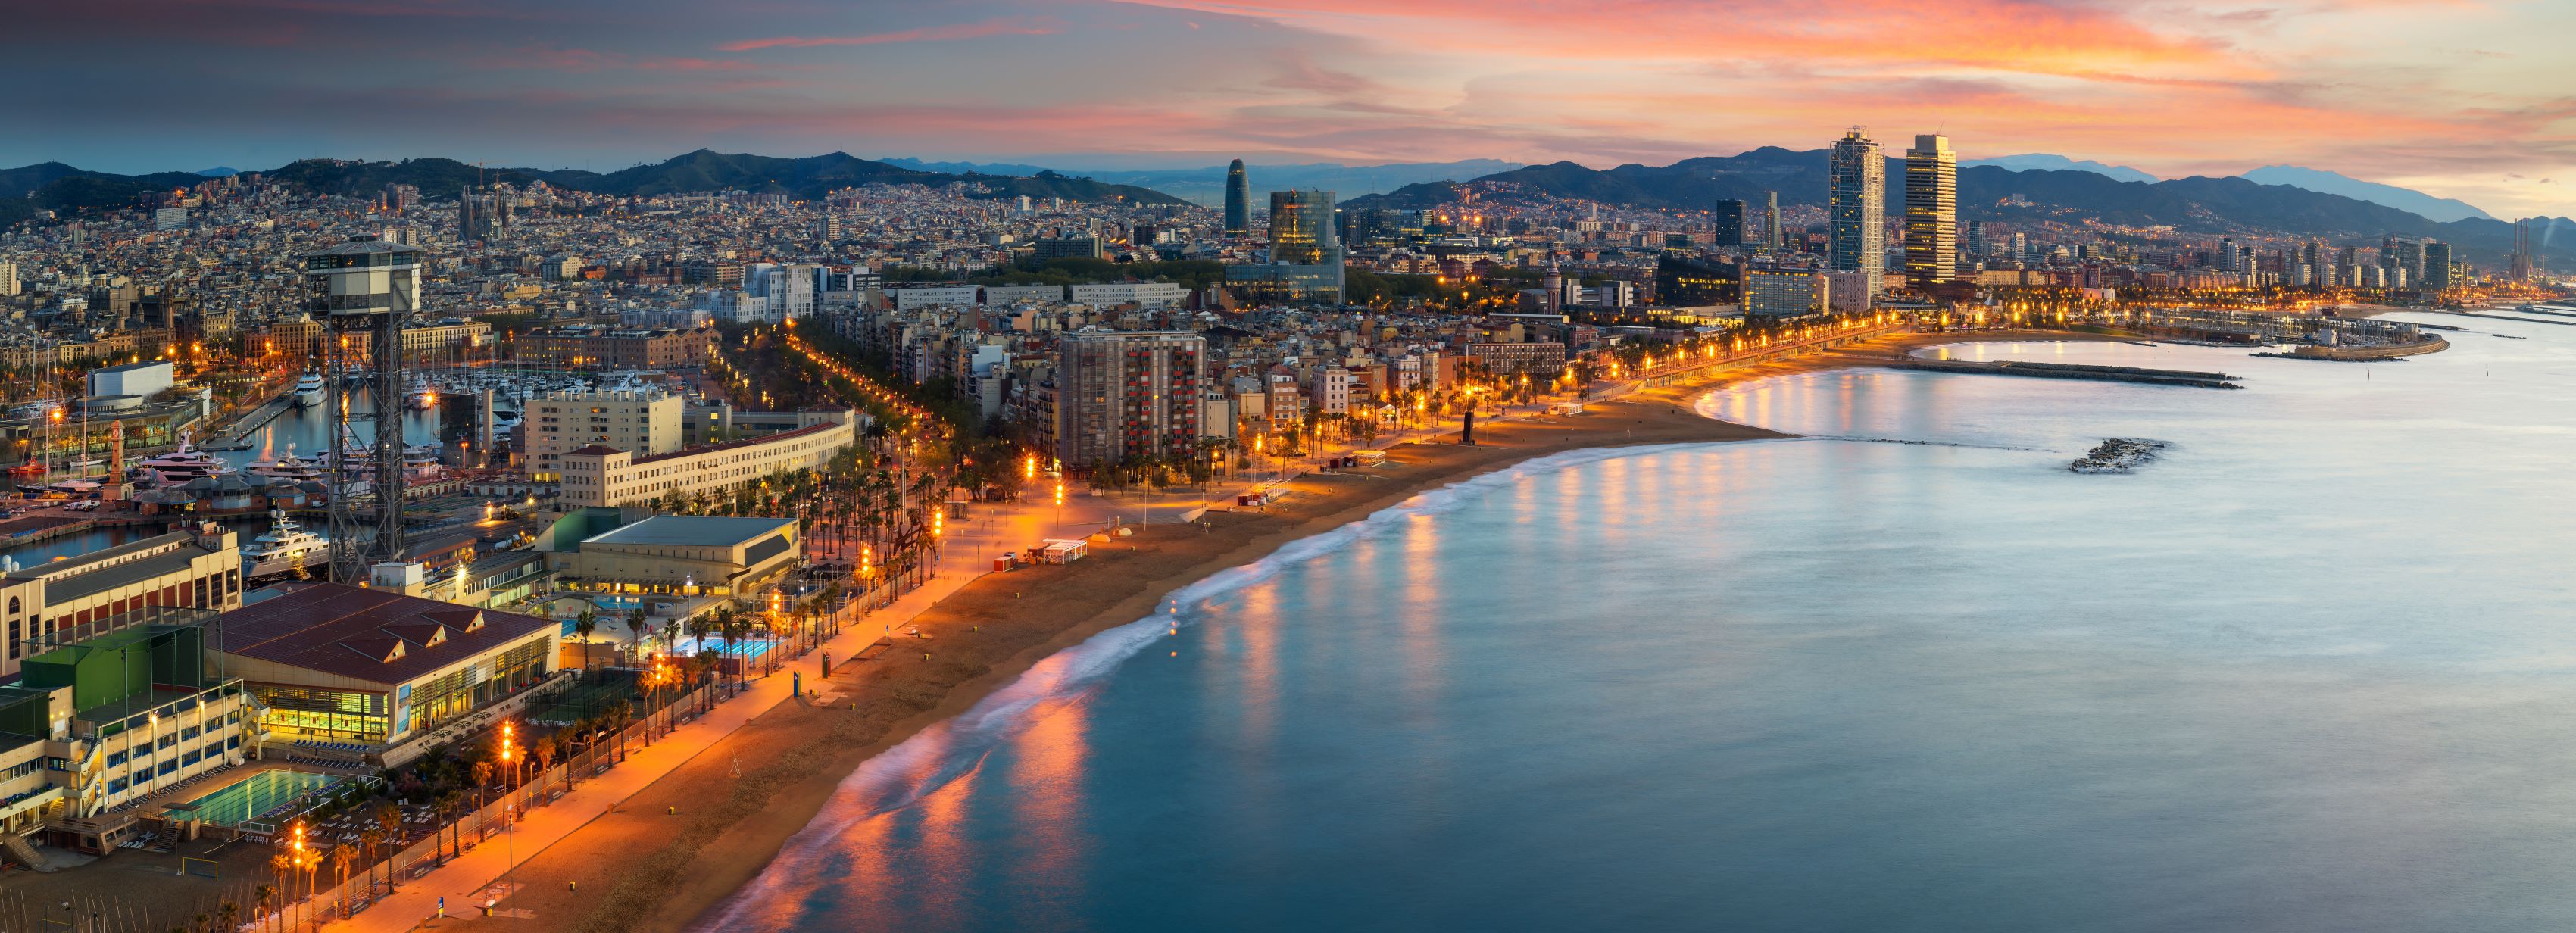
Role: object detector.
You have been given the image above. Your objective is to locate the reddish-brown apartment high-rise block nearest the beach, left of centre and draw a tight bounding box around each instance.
[1056,330,1208,469]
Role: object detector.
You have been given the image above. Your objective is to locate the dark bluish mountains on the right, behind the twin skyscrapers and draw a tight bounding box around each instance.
[1344,147,2576,257]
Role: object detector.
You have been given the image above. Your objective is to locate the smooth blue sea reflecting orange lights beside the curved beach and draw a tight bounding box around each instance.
[706,313,2576,931]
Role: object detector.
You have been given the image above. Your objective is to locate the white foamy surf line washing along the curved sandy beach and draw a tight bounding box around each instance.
[693,443,1708,933]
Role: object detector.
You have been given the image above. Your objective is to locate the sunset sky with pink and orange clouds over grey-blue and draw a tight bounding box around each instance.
[0,0,2576,217]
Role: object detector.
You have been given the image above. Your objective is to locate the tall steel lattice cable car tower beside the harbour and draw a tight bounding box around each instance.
[304,237,423,585]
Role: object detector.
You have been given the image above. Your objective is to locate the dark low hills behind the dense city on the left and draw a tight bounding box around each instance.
[0,149,1185,226]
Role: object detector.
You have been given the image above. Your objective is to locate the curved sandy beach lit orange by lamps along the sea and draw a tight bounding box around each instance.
[486,330,2125,933]
